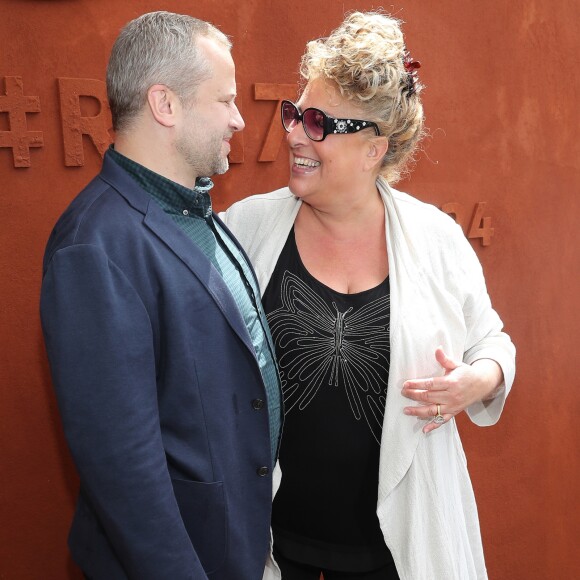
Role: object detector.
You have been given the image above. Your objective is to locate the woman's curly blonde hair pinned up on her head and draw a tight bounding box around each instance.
[300,12,424,183]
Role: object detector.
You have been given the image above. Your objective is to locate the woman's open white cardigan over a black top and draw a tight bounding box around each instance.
[221,178,515,580]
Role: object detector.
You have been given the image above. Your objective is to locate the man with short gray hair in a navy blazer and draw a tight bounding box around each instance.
[41,12,280,580]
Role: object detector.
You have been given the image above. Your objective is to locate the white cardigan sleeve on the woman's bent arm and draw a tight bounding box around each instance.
[456,227,516,426]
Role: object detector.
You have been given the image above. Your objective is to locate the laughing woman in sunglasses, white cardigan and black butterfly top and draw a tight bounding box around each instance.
[224,13,515,580]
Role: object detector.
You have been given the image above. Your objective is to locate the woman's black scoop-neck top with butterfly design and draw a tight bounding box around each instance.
[263,230,391,572]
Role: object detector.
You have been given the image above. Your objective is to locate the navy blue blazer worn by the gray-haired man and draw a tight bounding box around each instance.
[41,156,272,580]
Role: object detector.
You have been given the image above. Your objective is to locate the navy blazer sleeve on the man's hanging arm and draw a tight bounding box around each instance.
[41,245,206,580]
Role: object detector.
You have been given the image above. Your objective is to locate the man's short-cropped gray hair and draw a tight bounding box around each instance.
[107,11,232,132]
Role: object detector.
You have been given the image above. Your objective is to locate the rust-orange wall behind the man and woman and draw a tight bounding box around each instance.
[0,0,580,580]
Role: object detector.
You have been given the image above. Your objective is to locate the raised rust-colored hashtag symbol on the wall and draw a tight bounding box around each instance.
[0,77,44,167]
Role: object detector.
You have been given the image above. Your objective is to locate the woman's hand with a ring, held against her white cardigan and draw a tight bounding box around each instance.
[402,347,503,433]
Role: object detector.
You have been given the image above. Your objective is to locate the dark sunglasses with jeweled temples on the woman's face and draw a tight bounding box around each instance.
[281,101,381,141]
